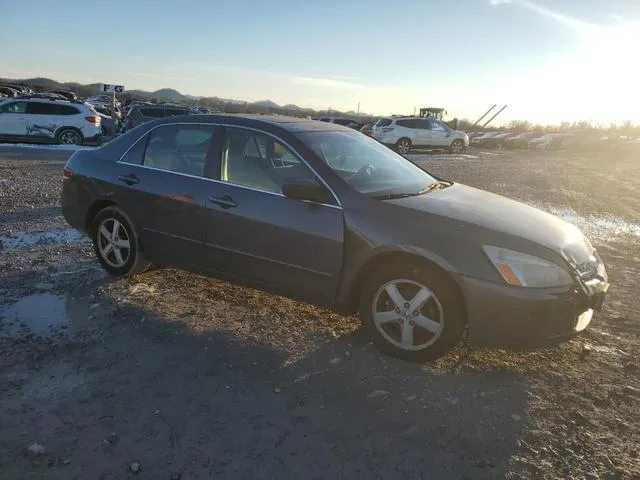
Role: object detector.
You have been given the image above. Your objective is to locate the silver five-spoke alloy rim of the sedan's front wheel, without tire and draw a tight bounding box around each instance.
[371,279,444,351]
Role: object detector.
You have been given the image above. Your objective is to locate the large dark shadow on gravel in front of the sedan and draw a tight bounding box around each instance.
[0,266,526,479]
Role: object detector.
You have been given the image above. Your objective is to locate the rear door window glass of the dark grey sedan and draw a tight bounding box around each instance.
[142,125,214,176]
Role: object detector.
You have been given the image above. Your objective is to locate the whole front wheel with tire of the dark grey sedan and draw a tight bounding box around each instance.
[360,262,466,362]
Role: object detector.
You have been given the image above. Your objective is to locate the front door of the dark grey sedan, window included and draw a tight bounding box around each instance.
[206,127,344,303]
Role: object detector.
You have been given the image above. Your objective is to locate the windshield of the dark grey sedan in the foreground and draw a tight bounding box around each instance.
[298,131,436,197]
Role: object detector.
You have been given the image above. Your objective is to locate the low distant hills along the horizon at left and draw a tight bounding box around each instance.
[0,77,369,120]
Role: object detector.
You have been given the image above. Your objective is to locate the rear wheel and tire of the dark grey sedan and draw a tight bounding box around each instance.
[90,206,151,277]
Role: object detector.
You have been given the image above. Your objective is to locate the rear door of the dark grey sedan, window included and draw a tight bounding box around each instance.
[113,123,216,270]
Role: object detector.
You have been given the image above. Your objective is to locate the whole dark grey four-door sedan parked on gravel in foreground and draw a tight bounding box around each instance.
[62,115,609,361]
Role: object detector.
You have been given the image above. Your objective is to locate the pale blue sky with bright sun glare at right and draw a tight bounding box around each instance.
[0,0,640,124]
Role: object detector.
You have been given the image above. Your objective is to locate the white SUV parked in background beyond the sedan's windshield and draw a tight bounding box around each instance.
[371,117,469,154]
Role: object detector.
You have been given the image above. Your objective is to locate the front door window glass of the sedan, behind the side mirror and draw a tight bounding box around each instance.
[220,128,315,193]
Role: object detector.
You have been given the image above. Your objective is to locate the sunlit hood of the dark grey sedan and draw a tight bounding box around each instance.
[392,183,593,263]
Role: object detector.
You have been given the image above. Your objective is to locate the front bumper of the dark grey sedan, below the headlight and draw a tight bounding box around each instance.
[458,276,609,348]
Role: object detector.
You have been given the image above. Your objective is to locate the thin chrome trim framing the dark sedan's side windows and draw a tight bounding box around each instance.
[116,122,343,210]
